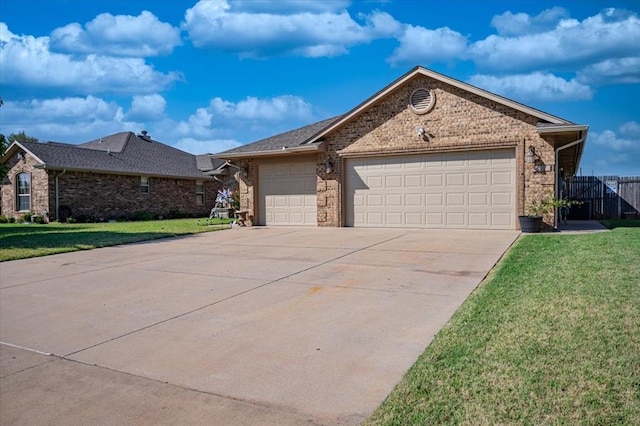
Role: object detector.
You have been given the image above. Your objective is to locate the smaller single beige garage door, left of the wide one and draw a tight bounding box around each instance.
[258,162,318,226]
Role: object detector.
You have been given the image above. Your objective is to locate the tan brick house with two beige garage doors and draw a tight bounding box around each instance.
[216,67,588,229]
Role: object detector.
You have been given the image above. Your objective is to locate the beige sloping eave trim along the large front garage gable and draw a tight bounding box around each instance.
[305,66,569,143]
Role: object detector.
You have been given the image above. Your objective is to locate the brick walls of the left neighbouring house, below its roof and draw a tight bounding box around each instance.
[2,153,228,220]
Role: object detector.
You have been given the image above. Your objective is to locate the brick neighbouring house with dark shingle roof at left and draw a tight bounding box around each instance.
[0,132,235,220]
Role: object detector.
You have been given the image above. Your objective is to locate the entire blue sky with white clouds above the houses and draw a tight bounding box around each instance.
[0,0,640,176]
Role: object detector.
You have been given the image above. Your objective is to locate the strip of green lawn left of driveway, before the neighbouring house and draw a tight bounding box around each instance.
[0,219,229,262]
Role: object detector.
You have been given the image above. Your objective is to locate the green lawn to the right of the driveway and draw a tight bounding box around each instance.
[366,228,640,426]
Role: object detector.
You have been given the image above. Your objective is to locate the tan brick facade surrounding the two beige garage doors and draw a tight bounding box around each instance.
[235,75,555,231]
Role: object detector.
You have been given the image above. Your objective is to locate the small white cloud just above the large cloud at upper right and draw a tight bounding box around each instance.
[491,7,569,37]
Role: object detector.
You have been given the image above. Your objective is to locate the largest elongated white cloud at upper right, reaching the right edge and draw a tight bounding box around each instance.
[469,9,640,72]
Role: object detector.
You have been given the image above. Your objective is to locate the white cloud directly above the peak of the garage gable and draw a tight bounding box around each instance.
[387,25,467,64]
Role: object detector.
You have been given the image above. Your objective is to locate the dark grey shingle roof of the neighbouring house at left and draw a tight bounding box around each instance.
[21,132,208,179]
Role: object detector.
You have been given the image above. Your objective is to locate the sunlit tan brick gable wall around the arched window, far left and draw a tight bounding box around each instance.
[1,152,51,218]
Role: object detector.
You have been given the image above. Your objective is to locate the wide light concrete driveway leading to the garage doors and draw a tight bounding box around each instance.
[0,227,518,425]
